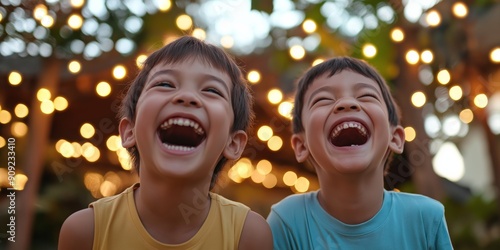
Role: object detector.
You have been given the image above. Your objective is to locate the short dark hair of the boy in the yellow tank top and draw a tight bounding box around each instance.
[118,36,254,189]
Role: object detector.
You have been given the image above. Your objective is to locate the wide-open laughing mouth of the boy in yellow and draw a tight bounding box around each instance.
[158,117,206,151]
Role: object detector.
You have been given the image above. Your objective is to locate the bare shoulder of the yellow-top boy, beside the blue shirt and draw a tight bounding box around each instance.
[239,211,273,250]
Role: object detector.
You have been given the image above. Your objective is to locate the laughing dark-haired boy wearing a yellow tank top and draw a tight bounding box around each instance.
[59,36,272,250]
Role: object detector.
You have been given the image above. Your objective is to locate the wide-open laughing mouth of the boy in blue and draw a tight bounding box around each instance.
[330,121,369,147]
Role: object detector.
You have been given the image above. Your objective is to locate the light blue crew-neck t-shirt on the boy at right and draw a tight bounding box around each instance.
[267,190,453,250]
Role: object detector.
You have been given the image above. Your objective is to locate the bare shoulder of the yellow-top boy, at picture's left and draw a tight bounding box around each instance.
[58,208,94,250]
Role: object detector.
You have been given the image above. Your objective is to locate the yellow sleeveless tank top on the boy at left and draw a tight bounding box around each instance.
[89,183,250,250]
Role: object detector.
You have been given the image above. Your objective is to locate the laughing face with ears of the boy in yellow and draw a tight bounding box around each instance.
[120,57,246,182]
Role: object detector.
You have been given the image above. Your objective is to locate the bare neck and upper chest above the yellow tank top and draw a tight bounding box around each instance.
[134,171,210,243]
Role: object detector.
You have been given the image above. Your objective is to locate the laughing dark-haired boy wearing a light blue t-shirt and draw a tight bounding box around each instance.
[267,57,453,250]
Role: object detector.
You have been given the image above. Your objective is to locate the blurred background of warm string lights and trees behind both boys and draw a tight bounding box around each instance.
[0,0,500,249]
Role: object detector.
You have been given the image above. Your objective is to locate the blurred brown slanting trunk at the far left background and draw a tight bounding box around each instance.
[9,58,61,250]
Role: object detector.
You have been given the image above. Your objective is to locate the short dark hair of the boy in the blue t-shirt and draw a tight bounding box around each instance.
[292,57,400,134]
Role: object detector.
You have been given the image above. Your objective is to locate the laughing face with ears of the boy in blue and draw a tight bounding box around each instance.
[292,70,404,174]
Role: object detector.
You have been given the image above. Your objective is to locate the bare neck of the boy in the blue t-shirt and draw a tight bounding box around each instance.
[318,170,384,224]
